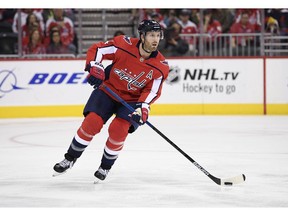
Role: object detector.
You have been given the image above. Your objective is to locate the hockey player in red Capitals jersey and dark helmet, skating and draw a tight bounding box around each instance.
[54,20,169,180]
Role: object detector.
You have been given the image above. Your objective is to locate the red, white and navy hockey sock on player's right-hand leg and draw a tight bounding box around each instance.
[100,117,130,170]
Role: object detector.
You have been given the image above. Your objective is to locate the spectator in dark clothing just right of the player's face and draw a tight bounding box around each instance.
[159,22,189,56]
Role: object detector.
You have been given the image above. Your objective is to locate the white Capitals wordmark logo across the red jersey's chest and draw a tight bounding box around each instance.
[114,68,147,91]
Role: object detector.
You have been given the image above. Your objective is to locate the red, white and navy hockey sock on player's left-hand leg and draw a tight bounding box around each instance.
[66,112,104,160]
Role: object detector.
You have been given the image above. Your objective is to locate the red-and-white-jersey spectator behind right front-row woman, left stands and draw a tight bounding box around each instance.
[46,8,76,53]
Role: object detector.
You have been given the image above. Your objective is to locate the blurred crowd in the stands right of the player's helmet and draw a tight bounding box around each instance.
[133,9,288,56]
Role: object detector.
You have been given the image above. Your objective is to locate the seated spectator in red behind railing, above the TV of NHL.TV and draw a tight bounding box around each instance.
[230,11,255,55]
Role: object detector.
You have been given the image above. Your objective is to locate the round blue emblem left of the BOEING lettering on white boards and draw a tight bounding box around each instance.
[0,70,25,98]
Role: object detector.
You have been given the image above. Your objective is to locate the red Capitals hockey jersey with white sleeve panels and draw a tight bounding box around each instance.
[86,35,169,104]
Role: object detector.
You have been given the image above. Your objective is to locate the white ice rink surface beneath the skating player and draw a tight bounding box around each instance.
[0,116,288,211]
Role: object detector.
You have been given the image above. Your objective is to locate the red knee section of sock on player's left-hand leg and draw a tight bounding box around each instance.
[80,112,104,136]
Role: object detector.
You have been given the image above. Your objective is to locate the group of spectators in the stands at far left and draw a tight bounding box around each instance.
[0,9,77,55]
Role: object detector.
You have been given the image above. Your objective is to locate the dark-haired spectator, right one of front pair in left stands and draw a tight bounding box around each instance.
[46,30,75,54]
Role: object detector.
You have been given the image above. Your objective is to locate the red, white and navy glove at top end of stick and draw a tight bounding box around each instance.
[85,61,105,88]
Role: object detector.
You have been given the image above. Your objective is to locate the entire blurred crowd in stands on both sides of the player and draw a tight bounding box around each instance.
[0,9,288,56]
